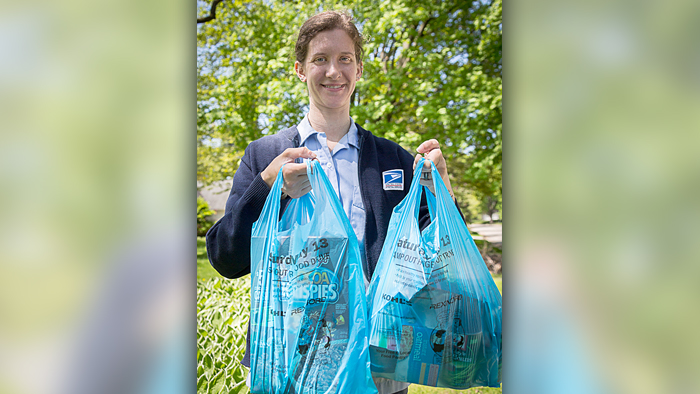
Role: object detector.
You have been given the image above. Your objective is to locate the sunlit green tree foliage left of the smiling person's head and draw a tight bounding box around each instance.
[197,0,315,185]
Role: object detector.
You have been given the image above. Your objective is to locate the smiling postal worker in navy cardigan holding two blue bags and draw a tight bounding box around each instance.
[207,11,464,394]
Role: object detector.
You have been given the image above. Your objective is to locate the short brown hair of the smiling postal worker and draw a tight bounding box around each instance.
[294,11,364,64]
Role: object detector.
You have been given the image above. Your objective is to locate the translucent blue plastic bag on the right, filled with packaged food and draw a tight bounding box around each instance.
[368,159,502,389]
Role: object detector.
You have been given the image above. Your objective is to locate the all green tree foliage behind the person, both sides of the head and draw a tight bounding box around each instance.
[197,0,502,222]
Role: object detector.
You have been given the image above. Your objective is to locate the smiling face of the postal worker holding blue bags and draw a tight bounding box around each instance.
[294,29,362,112]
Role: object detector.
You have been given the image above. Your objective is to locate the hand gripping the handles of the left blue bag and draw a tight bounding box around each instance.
[260,147,316,198]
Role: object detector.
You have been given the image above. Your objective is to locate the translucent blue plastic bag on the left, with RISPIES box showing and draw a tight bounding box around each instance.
[250,161,377,394]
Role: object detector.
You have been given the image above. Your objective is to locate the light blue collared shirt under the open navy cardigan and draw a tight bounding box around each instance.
[297,114,369,285]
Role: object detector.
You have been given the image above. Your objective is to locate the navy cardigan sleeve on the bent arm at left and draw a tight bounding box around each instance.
[206,146,270,279]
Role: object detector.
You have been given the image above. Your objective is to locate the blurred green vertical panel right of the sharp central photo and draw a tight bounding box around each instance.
[504,0,700,394]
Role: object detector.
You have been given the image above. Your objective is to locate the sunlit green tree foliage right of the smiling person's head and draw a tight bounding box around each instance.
[351,0,502,220]
